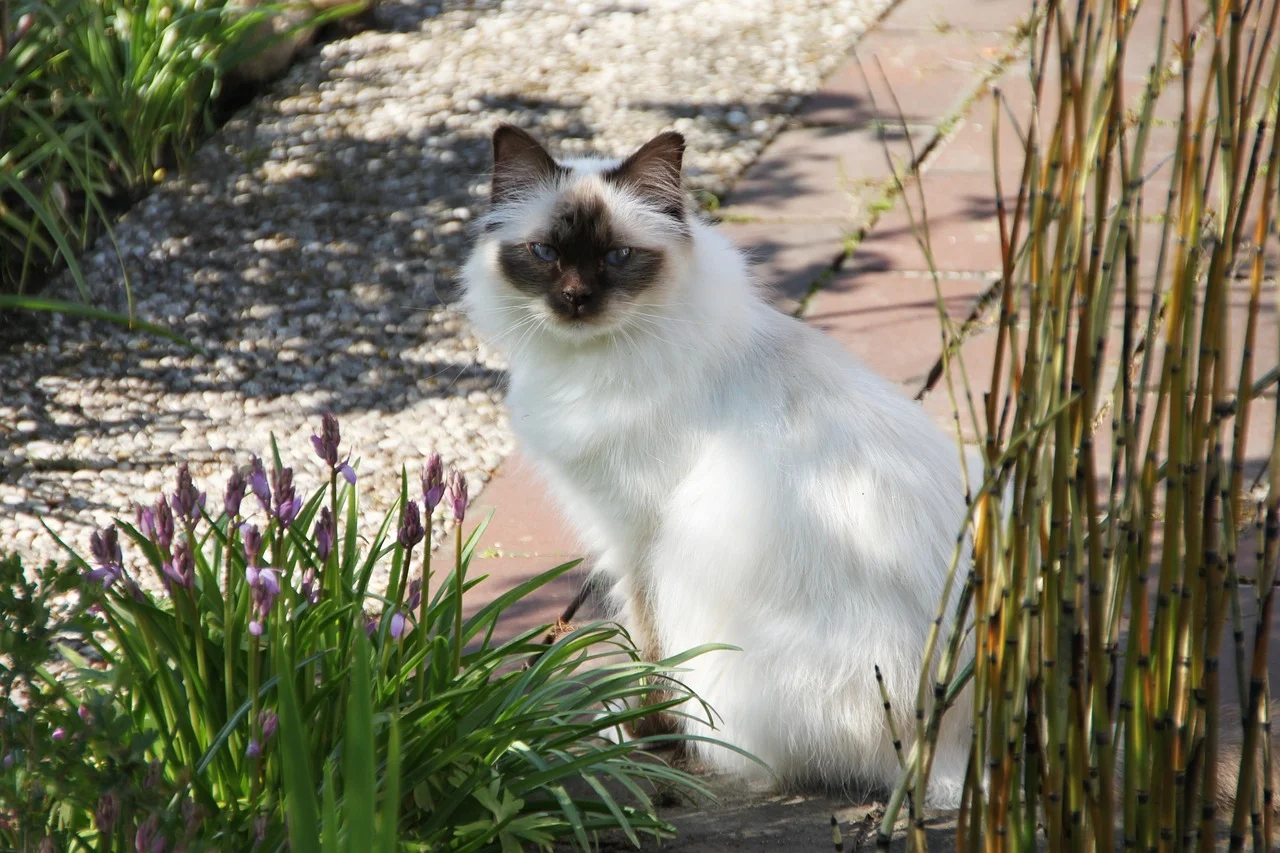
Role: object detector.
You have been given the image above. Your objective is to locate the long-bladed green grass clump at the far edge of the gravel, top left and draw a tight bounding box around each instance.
[0,0,340,310]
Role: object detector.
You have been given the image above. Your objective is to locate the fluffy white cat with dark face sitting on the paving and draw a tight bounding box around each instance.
[462,126,969,806]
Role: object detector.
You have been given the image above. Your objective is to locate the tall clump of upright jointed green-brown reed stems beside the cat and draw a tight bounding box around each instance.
[882,0,1280,850]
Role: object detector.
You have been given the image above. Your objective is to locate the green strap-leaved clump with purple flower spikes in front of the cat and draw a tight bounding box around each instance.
[15,416,727,850]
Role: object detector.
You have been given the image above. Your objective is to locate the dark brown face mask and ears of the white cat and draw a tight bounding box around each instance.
[493,126,686,324]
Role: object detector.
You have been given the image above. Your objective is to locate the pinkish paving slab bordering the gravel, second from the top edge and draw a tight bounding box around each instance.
[796,29,1009,126]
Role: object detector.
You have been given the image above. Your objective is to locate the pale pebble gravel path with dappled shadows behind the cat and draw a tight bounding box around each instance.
[0,0,887,581]
